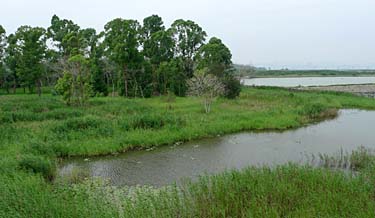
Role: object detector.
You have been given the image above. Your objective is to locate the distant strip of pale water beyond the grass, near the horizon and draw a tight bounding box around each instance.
[243,77,375,87]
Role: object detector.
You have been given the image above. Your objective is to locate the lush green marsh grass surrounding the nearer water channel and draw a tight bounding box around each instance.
[0,87,375,217]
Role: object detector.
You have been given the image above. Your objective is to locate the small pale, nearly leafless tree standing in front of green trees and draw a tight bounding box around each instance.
[188,69,225,113]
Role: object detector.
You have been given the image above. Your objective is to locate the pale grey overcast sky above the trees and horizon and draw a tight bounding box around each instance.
[0,0,375,68]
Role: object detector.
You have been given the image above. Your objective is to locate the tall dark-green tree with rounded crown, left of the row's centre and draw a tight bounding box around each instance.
[104,18,142,97]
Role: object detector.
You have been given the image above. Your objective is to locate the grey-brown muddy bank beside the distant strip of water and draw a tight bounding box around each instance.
[297,84,375,98]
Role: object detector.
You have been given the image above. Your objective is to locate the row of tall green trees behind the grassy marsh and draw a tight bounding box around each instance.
[0,15,240,103]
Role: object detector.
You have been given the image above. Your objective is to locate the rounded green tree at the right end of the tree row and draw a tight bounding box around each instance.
[196,37,241,98]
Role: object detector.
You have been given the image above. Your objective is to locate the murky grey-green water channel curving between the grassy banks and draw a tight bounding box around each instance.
[59,110,375,186]
